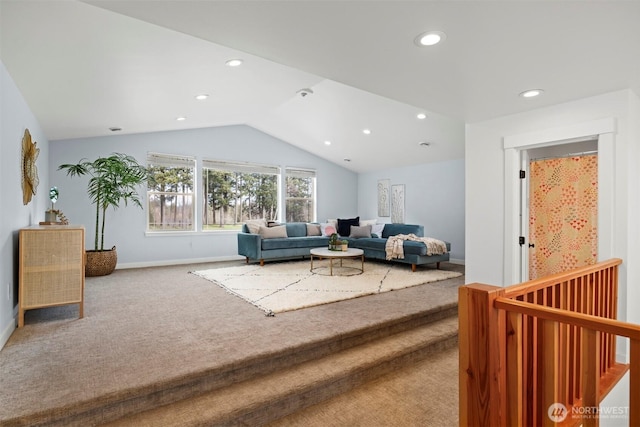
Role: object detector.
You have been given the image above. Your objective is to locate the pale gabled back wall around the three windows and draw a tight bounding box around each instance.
[49,126,357,268]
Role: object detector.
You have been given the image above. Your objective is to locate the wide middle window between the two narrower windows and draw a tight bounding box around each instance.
[202,159,280,230]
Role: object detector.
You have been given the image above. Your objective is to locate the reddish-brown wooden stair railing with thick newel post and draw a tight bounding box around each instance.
[458,259,640,427]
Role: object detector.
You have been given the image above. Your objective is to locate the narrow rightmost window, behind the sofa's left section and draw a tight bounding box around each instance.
[285,168,316,222]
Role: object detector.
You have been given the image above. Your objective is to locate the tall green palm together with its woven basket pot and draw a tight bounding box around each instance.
[58,153,149,276]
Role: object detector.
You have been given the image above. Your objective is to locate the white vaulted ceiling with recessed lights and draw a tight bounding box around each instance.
[0,0,640,172]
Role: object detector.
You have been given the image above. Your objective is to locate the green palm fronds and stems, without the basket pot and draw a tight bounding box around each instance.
[58,153,149,251]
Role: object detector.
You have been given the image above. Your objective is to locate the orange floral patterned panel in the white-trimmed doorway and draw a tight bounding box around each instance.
[529,155,598,279]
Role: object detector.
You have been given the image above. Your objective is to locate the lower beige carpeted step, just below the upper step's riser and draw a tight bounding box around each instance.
[102,316,458,427]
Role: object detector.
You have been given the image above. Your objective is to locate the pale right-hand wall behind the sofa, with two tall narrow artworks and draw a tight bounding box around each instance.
[358,159,465,263]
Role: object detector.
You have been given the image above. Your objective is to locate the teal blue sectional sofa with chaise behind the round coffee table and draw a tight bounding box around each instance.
[238,222,451,271]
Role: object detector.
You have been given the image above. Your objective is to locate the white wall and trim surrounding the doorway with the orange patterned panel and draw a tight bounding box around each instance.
[465,90,640,414]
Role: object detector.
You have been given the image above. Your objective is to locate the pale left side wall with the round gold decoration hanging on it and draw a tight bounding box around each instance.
[0,62,49,348]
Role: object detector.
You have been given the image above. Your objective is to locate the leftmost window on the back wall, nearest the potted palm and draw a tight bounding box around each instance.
[147,153,196,231]
